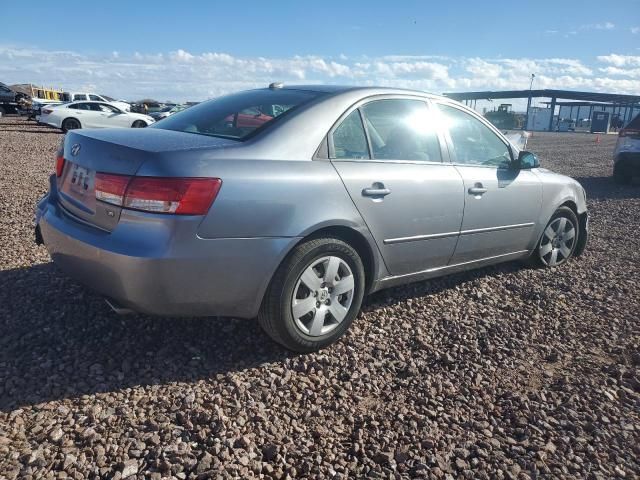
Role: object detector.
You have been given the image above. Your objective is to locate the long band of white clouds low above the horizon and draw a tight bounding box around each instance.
[0,45,640,101]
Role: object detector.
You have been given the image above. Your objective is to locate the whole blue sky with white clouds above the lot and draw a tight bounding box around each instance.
[0,0,640,100]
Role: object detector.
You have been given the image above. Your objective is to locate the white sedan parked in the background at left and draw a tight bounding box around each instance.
[38,102,155,132]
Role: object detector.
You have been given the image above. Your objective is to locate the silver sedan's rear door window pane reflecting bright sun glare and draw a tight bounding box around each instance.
[362,99,442,162]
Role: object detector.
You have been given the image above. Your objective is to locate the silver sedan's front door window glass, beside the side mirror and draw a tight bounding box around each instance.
[439,104,511,168]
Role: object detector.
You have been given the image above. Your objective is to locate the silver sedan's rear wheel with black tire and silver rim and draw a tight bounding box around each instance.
[258,237,364,353]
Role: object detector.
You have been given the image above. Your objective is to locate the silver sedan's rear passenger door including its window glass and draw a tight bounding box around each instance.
[328,97,464,275]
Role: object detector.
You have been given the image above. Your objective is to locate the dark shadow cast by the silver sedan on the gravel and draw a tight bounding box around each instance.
[0,256,523,412]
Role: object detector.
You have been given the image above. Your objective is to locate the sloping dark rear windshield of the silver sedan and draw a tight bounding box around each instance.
[150,89,322,141]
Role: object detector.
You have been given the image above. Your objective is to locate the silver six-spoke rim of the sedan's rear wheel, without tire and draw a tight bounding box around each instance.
[291,256,355,337]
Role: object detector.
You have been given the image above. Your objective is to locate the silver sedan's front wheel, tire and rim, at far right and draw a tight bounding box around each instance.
[533,207,581,267]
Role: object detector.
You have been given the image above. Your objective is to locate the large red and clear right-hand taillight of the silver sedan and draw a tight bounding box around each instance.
[95,173,222,215]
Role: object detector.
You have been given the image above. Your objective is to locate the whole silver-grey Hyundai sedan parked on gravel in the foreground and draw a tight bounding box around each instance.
[36,84,588,352]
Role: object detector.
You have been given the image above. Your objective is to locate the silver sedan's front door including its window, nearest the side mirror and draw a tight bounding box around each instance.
[438,102,542,264]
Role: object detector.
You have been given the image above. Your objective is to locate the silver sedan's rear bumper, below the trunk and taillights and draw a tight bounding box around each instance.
[36,180,297,318]
